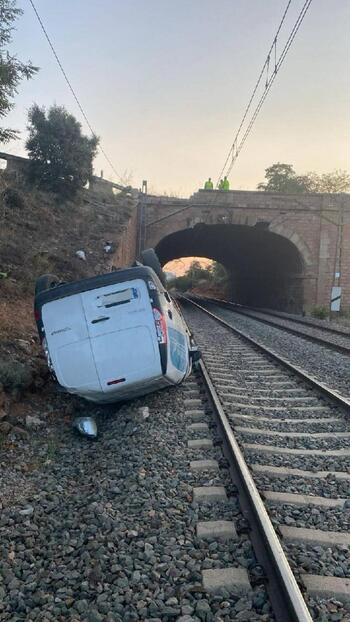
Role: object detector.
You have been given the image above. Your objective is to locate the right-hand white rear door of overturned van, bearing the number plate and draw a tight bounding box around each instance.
[81,279,162,393]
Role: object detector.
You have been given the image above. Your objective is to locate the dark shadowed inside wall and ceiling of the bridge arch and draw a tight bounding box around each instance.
[155,223,304,313]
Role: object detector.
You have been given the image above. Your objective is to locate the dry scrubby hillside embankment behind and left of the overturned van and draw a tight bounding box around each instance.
[0,177,135,428]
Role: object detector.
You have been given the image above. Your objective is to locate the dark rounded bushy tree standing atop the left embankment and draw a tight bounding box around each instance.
[26,104,98,193]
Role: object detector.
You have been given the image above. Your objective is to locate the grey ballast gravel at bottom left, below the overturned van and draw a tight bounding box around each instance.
[0,380,273,622]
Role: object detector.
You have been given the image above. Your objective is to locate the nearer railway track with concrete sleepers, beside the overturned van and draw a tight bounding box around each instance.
[184,299,350,622]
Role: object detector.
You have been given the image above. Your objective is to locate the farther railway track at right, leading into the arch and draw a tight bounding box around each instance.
[203,298,350,354]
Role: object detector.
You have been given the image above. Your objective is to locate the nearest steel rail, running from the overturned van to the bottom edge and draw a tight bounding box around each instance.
[190,334,312,622]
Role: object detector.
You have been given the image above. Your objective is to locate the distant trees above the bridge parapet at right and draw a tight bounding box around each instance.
[258,162,350,194]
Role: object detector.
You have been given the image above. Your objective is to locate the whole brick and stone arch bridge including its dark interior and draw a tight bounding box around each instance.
[137,190,350,311]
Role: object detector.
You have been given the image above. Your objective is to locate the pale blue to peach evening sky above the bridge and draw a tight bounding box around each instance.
[3,0,350,197]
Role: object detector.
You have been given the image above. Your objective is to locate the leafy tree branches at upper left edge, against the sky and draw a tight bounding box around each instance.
[0,0,38,143]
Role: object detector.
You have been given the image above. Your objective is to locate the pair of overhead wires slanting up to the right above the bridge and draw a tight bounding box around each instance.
[217,0,312,185]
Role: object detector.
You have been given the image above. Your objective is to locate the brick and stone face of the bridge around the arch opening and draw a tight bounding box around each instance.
[144,191,350,307]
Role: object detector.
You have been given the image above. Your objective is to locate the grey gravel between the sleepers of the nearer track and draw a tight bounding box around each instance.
[184,305,350,622]
